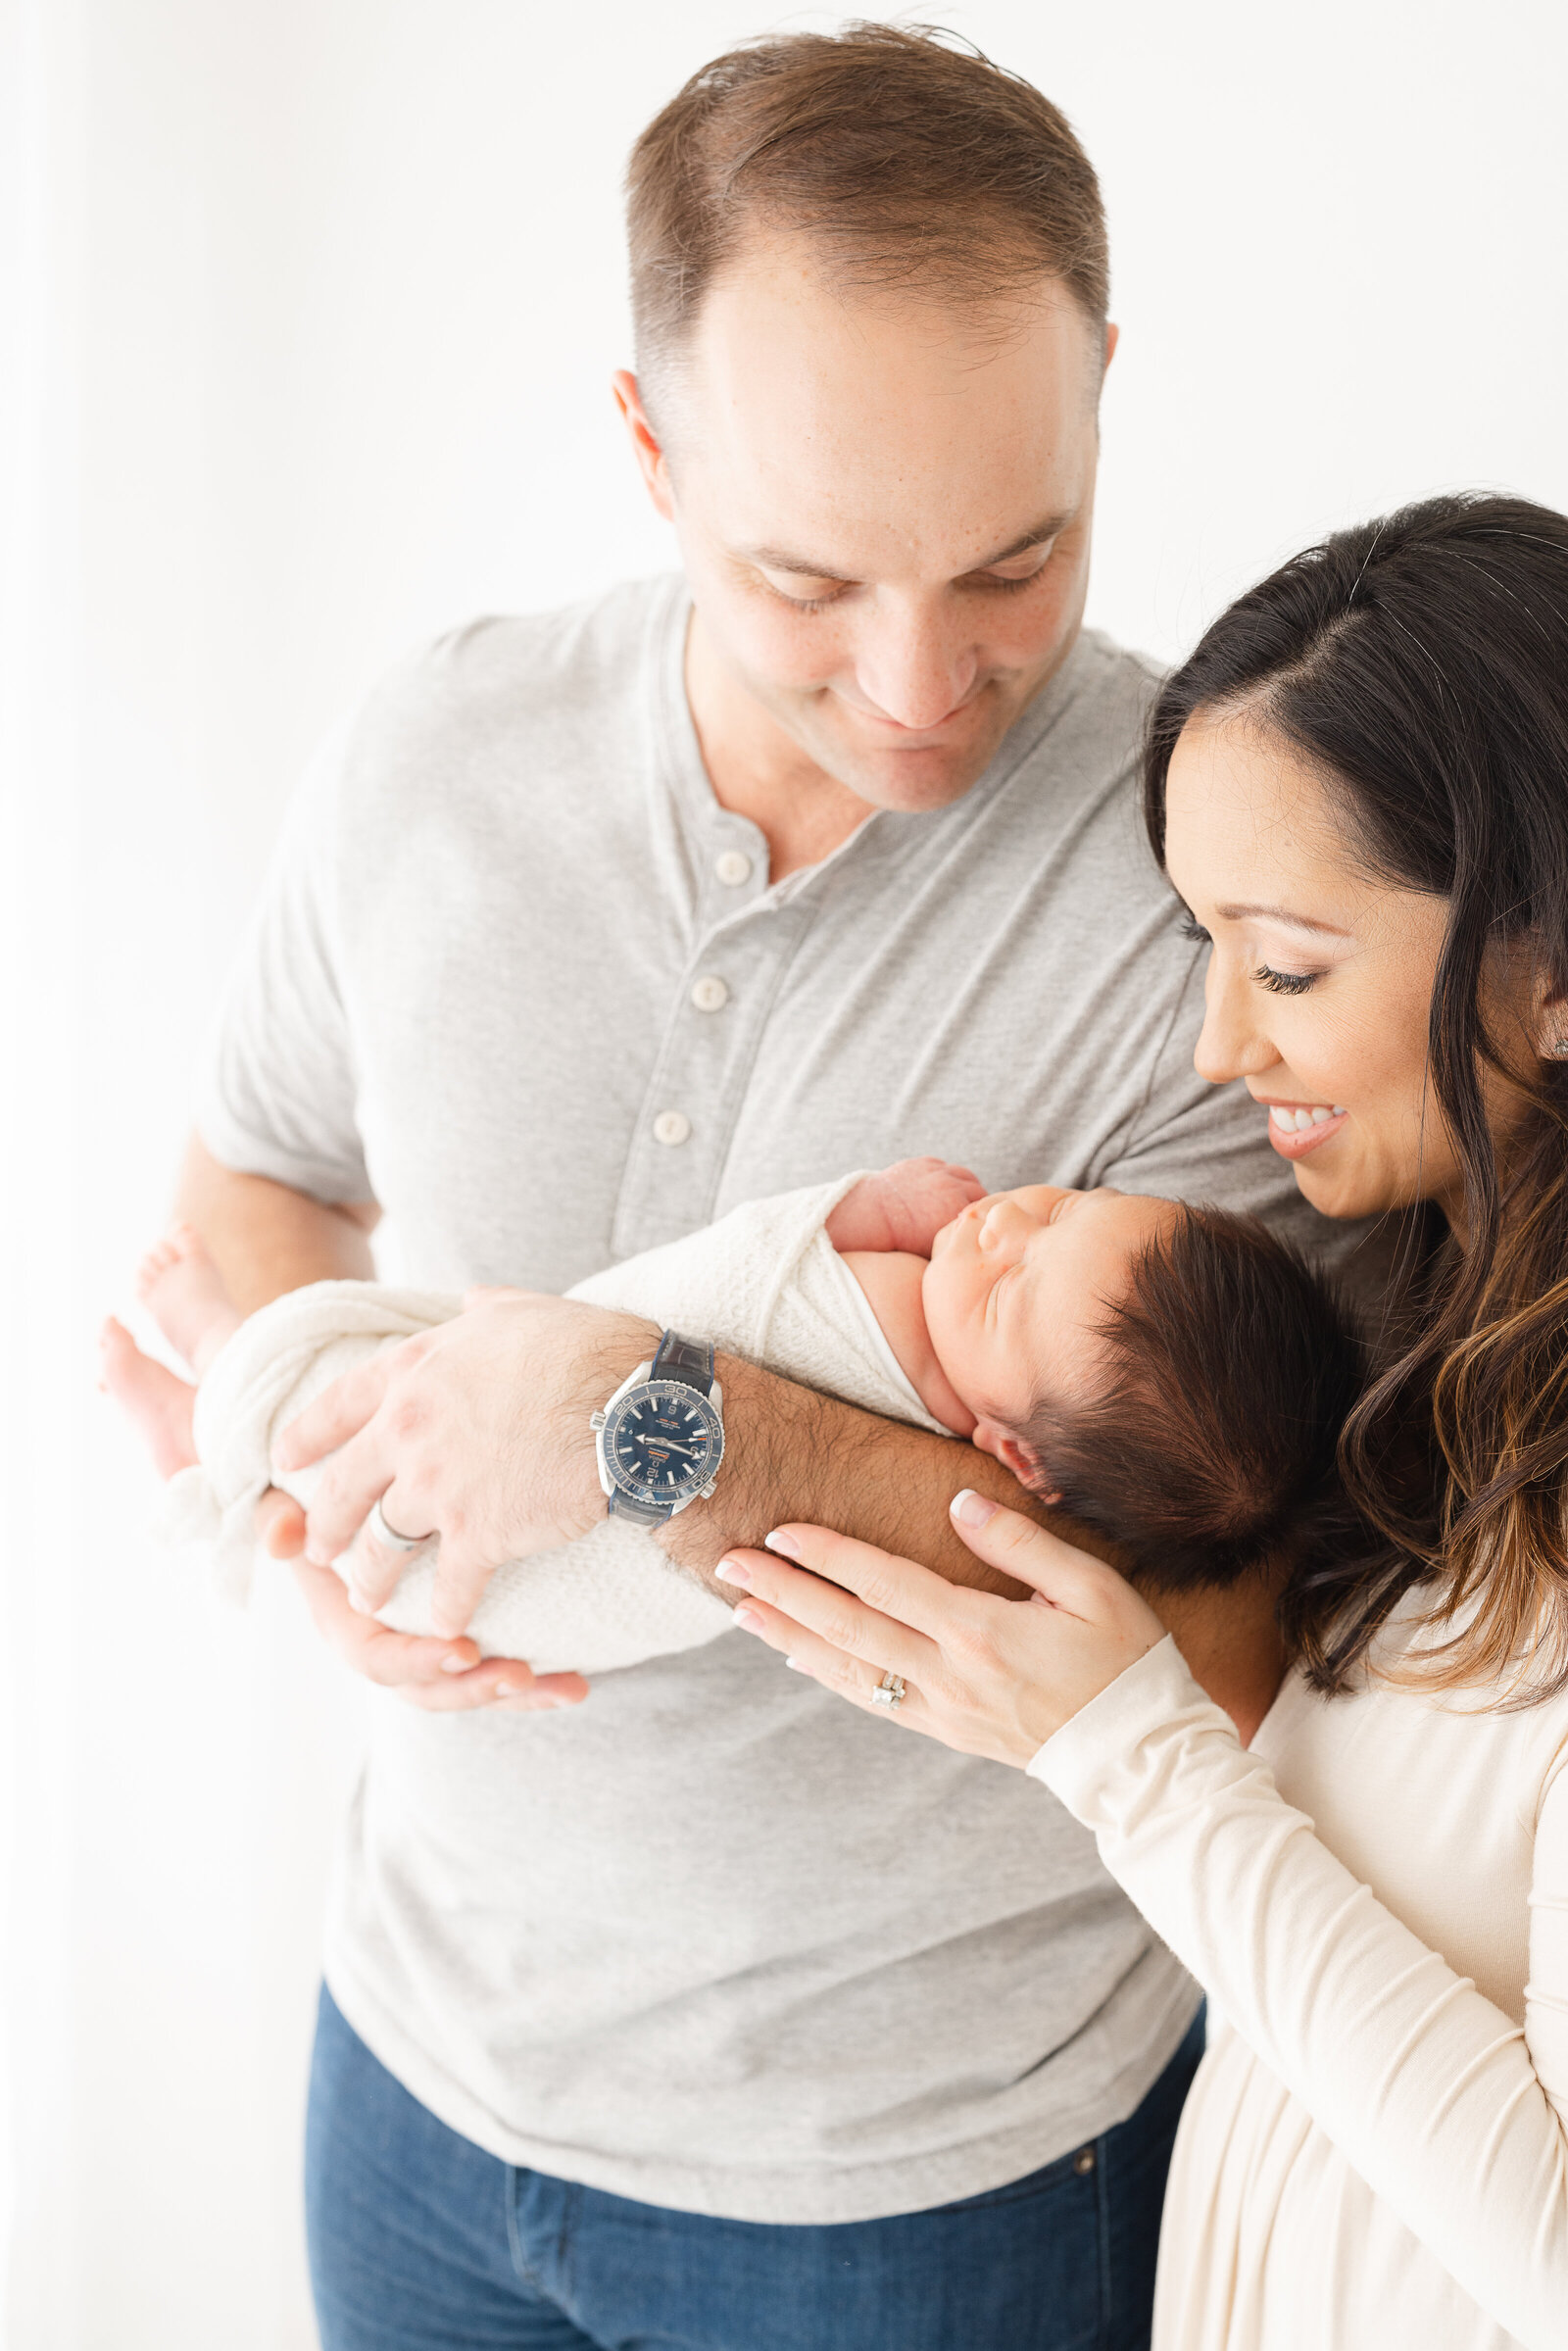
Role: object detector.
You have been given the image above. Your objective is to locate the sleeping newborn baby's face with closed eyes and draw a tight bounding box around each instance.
[921,1183,1178,1444]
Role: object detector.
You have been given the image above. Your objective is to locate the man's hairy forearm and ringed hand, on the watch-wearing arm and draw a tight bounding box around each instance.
[277,1291,1279,1721]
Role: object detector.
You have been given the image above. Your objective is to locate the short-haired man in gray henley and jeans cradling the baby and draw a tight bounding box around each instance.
[186,25,1363,2351]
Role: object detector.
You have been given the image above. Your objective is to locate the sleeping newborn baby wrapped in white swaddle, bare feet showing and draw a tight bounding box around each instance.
[106,1159,1359,1672]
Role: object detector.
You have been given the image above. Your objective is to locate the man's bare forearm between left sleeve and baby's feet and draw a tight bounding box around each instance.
[176,1136,381,1314]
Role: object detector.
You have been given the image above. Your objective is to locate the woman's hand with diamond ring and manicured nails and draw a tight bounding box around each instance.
[717,1493,1166,1766]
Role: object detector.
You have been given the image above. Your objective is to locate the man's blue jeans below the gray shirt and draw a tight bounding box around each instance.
[306,1991,1203,2351]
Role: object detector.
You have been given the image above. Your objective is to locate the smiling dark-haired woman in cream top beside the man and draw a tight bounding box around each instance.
[719,499,1568,2351]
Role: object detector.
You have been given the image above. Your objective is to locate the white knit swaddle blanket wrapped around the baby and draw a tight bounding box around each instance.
[163,1176,941,1674]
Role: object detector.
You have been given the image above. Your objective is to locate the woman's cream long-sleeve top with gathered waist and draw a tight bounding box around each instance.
[1030,1613,1568,2351]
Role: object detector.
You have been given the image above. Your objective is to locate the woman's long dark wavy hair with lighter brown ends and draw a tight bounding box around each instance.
[1145,496,1568,1702]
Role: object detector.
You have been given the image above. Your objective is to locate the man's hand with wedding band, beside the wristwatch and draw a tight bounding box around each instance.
[272,1291,659,1639]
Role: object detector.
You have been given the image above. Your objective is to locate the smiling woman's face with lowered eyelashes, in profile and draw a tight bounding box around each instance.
[1166,714,1462,1222]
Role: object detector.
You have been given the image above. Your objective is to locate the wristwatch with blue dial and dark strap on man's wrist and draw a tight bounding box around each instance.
[590,1331,724,1526]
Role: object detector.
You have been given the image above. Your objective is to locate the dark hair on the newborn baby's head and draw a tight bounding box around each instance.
[1015,1208,1363,1592]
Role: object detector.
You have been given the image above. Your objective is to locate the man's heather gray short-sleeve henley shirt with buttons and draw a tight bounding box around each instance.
[200,581,1363,2222]
